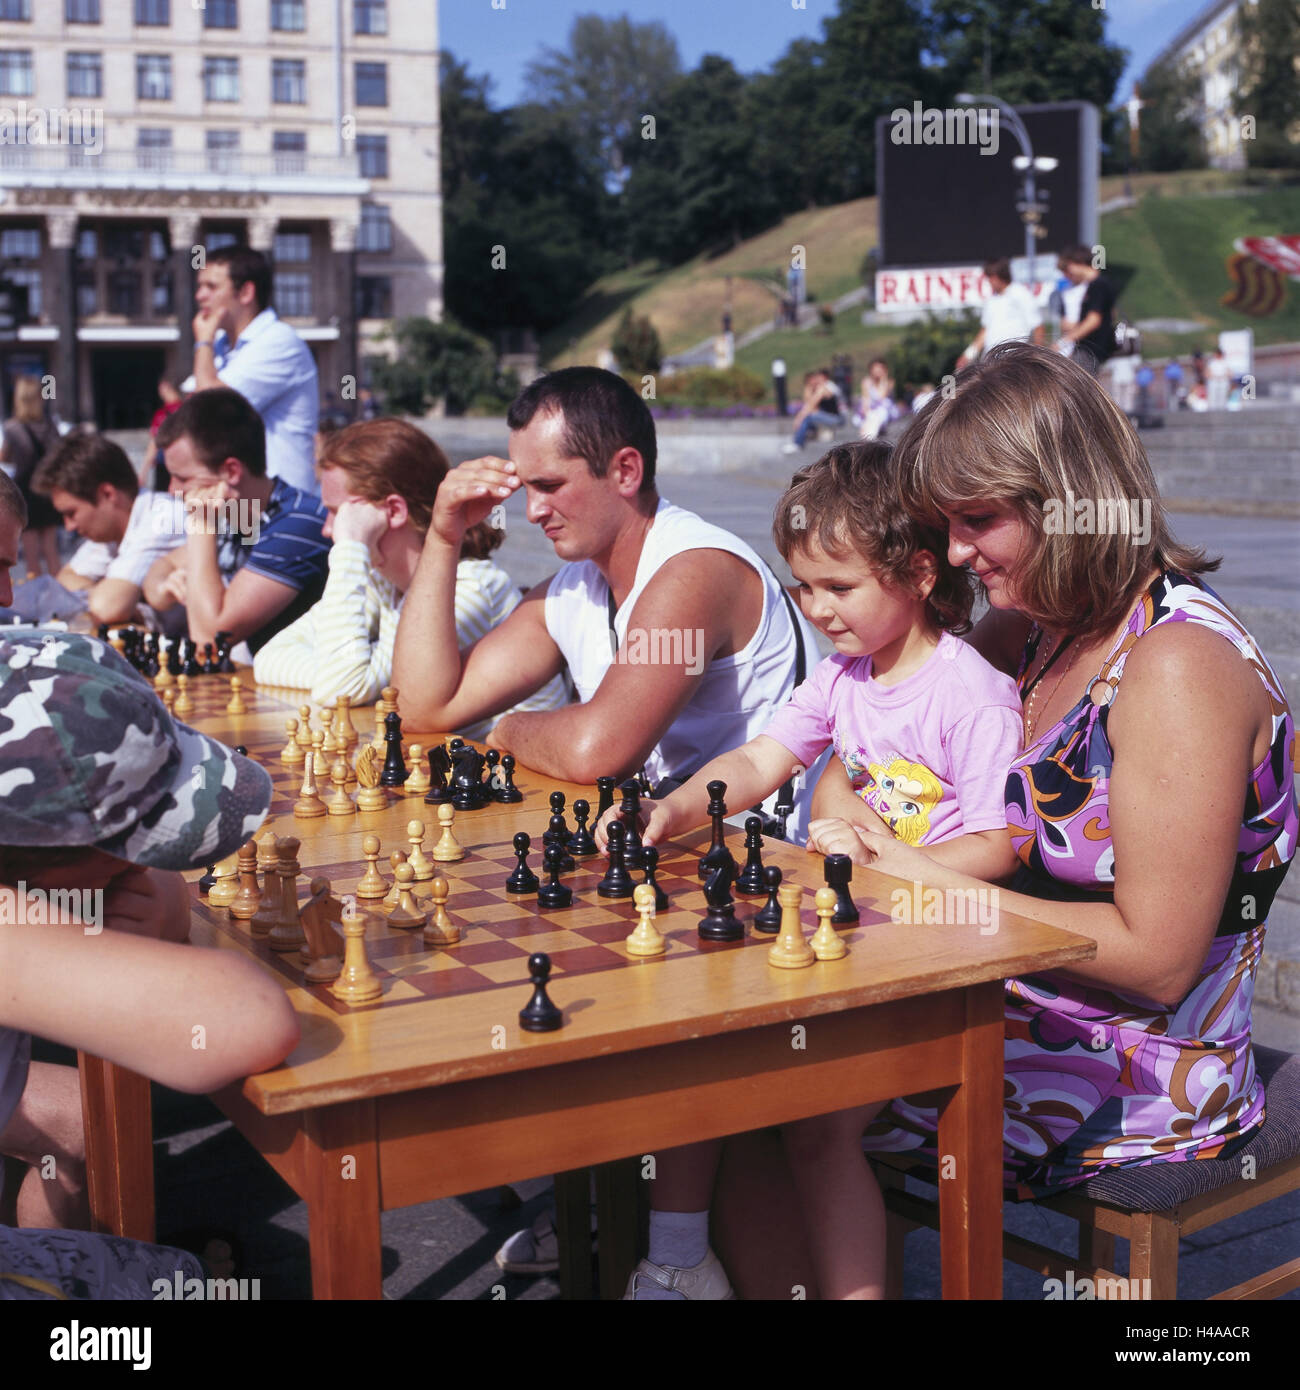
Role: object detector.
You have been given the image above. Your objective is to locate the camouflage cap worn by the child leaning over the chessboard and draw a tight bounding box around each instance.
[0,628,271,869]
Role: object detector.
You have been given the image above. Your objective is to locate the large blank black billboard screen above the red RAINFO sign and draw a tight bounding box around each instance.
[876,101,1100,267]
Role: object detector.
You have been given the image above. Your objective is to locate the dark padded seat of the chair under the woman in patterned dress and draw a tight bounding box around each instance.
[1072,1045,1300,1212]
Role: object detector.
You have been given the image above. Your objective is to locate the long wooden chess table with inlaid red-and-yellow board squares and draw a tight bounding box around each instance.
[82,673,1096,1298]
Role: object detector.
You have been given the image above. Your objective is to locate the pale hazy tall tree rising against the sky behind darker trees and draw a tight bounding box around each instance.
[526,14,681,188]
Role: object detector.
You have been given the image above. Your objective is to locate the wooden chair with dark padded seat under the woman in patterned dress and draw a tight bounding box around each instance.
[872,1045,1300,1298]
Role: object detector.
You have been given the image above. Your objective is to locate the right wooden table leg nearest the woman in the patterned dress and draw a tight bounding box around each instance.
[939,980,1005,1298]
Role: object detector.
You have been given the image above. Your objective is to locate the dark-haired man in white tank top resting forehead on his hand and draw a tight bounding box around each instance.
[393,367,816,838]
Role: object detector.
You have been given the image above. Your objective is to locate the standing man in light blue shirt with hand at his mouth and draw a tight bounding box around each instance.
[186,246,320,492]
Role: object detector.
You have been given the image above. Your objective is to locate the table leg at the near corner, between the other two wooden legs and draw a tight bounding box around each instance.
[303,1101,384,1298]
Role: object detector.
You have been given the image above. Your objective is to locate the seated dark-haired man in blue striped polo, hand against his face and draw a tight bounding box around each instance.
[145,386,330,652]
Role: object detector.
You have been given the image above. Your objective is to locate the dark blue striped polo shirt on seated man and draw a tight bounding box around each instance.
[217,478,330,652]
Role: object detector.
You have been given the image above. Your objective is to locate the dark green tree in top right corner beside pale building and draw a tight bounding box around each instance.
[1236,0,1300,168]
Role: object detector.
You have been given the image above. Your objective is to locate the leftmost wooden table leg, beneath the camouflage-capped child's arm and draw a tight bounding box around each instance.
[76,1052,154,1240]
